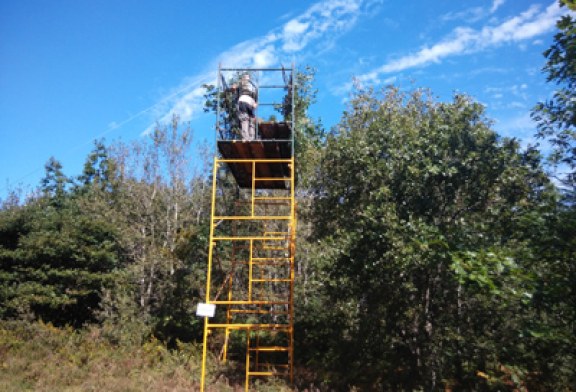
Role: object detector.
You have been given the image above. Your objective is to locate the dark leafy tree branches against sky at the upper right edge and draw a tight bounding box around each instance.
[532,1,576,192]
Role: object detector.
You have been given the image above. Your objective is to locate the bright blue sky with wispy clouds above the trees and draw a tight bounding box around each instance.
[0,0,568,199]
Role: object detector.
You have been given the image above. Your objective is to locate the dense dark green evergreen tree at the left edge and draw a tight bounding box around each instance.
[0,181,121,326]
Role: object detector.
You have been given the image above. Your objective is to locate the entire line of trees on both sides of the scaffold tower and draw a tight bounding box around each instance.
[0,10,576,391]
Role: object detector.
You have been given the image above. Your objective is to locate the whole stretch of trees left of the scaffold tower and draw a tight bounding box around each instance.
[0,121,211,342]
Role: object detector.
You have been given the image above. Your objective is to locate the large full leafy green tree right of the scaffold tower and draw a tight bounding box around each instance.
[304,88,564,390]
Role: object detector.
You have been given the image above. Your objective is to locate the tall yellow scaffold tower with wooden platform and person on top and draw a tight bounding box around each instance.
[197,65,296,391]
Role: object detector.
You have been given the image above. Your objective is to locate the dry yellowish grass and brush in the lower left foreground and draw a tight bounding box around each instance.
[0,321,290,392]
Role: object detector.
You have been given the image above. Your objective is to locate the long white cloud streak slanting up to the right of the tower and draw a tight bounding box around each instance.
[358,1,567,87]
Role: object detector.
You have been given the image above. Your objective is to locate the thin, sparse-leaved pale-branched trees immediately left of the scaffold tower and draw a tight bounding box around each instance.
[102,116,209,340]
